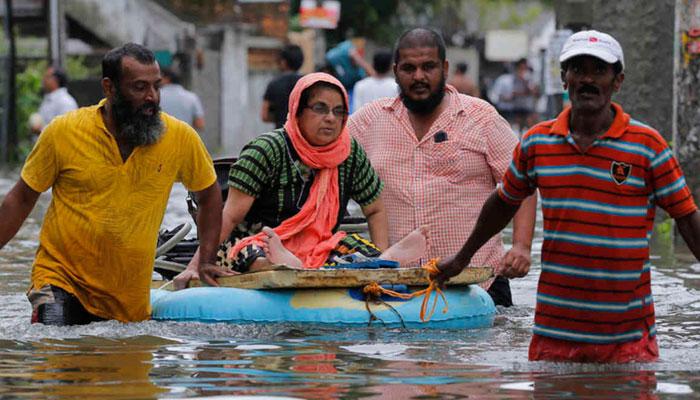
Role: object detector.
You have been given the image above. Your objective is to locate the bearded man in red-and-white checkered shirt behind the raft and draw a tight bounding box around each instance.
[348,28,537,306]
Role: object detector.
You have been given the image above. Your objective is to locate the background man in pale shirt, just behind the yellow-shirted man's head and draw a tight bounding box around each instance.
[160,68,204,133]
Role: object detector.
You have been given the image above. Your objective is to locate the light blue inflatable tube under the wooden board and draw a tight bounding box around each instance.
[151,285,496,329]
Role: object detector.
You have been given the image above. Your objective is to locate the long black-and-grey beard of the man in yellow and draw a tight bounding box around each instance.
[112,89,163,147]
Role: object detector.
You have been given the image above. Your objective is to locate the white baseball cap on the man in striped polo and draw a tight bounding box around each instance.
[559,30,625,69]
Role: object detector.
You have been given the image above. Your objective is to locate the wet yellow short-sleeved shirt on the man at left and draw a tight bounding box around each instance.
[22,100,216,322]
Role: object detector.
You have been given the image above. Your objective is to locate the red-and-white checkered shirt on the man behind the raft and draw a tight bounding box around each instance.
[348,85,518,276]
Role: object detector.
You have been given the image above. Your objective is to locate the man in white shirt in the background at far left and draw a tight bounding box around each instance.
[29,67,78,134]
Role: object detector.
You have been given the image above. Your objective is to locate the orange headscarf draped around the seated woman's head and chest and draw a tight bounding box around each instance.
[229,73,350,269]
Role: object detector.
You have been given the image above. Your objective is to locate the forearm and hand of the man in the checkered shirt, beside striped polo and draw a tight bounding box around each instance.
[494,193,537,278]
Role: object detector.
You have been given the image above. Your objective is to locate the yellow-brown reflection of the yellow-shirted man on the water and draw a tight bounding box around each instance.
[0,337,169,398]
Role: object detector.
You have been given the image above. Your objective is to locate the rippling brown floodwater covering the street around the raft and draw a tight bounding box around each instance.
[0,173,700,399]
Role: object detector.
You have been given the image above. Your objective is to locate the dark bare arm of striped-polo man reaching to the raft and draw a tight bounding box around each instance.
[435,190,519,284]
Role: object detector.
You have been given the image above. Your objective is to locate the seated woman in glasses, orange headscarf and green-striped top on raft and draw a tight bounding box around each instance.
[175,73,427,287]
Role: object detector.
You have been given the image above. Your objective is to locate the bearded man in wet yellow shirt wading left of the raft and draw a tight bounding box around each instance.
[0,43,230,325]
